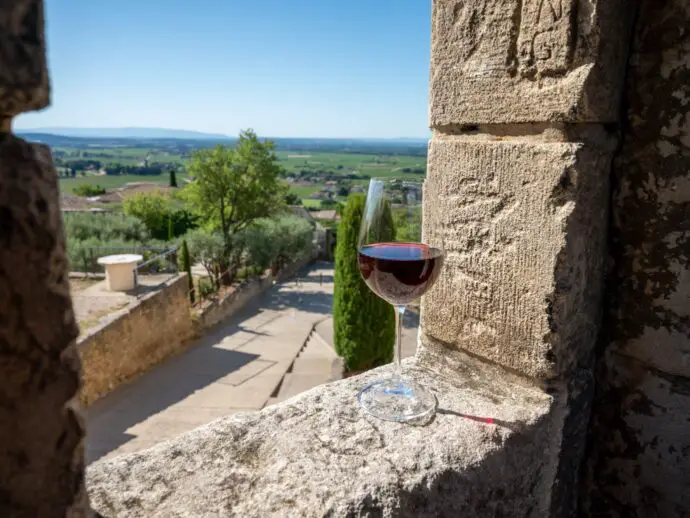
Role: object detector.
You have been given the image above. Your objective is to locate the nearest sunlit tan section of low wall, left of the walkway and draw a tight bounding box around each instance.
[77,274,194,405]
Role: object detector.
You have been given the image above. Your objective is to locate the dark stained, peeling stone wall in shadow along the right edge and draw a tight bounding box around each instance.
[583,0,690,518]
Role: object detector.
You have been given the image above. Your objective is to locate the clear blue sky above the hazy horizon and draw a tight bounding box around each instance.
[15,0,431,138]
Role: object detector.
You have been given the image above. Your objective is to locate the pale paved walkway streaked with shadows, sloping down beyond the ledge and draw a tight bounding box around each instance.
[86,263,335,462]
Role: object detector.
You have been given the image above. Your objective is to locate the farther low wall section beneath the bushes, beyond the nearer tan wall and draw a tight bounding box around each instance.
[195,254,315,332]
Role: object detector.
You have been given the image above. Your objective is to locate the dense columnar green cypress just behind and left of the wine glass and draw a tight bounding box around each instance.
[333,194,395,371]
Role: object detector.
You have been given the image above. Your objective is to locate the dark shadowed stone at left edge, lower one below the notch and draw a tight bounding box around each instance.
[0,136,88,517]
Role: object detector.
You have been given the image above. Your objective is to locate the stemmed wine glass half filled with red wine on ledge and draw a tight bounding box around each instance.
[358,179,443,421]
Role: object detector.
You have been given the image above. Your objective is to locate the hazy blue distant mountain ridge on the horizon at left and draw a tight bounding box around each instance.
[17,127,230,140]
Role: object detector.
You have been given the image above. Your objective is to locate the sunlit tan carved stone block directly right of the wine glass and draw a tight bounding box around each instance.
[421,138,611,378]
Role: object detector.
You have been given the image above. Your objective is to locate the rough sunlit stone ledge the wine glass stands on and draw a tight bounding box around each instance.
[86,358,565,518]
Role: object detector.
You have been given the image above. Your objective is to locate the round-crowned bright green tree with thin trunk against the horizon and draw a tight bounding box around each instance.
[183,130,287,284]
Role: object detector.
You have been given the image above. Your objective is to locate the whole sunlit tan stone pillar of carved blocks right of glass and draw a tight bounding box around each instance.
[420,0,630,517]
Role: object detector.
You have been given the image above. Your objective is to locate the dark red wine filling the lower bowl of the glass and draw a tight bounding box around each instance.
[358,242,443,306]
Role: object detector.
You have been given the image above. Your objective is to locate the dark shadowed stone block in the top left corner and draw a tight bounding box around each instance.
[0,0,50,119]
